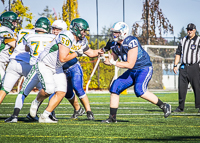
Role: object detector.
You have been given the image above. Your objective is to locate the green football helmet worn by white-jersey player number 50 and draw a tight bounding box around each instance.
[70,18,90,39]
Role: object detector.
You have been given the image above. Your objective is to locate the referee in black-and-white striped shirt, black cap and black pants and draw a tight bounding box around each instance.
[173,23,200,112]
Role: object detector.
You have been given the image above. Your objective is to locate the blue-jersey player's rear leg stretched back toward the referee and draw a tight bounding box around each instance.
[132,67,171,118]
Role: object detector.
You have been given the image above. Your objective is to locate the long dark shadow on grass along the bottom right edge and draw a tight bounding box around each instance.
[123,136,200,142]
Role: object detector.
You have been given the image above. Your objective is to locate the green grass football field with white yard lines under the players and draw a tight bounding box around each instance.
[0,93,200,143]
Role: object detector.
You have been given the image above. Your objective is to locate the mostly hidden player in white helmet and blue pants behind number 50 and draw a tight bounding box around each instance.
[49,20,94,120]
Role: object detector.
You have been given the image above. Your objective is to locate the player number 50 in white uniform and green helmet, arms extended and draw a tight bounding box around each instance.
[30,18,101,123]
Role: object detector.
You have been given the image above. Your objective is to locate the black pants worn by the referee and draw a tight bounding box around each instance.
[178,63,200,110]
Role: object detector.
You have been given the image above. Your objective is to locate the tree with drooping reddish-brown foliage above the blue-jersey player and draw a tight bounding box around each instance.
[132,0,173,45]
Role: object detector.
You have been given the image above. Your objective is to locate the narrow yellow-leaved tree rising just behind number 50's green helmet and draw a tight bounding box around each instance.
[62,0,79,29]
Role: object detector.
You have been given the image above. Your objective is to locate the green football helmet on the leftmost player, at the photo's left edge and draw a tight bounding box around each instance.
[0,11,19,30]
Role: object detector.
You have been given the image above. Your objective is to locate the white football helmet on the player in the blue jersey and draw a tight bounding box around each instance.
[110,22,129,42]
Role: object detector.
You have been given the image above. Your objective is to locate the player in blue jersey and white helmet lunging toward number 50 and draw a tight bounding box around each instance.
[102,22,171,123]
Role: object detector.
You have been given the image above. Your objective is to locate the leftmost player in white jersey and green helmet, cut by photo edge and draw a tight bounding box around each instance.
[0,11,18,89]
